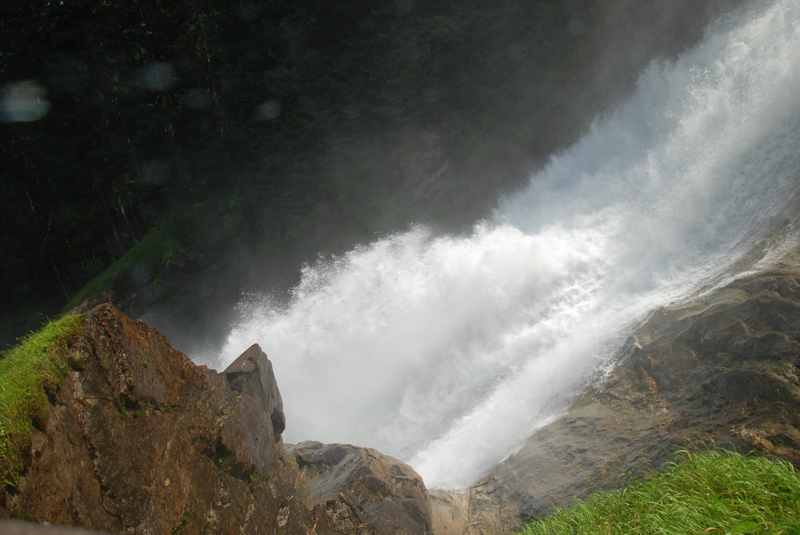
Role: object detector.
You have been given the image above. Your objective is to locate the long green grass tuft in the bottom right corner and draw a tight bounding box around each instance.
[521,452,800,535]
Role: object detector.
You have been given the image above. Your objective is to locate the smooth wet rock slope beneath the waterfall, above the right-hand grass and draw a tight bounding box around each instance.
[450,242,800,535]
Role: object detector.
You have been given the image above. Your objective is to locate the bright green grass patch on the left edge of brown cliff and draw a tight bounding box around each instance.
[0,314,82,485]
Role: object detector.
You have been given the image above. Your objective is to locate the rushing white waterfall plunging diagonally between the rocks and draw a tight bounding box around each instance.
[223,0,800,486]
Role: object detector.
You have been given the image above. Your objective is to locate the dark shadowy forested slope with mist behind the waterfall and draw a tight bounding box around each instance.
[0,0,741,351]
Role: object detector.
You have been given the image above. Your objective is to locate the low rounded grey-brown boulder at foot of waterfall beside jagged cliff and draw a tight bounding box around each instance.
[290,442,431,535]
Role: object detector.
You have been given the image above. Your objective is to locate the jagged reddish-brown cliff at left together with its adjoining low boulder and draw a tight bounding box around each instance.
[0,305,430,535]
